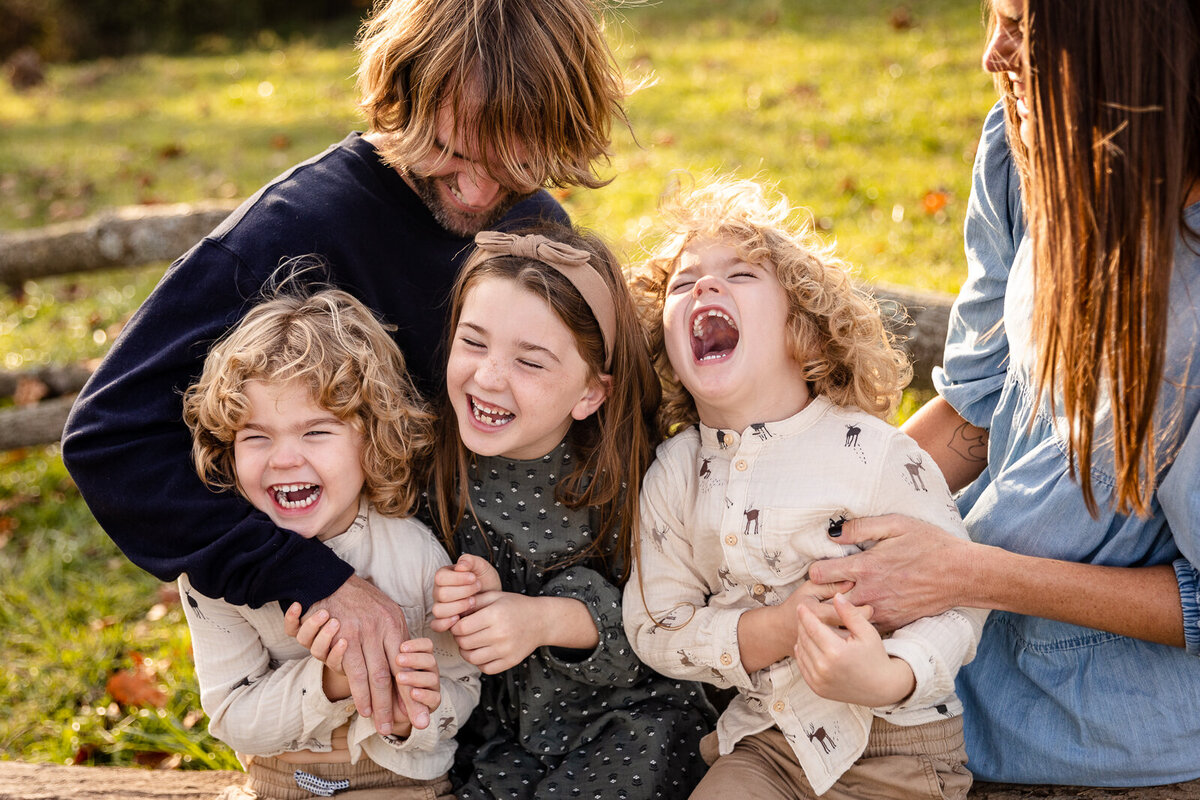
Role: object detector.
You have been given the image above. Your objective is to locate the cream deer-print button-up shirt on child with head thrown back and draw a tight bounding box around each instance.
[624,397,986,793]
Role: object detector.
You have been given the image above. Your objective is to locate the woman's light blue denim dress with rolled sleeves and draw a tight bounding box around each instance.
[935,104,1200,786]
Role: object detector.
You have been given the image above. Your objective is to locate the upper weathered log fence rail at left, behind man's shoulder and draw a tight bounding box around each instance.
[0,200,236,285]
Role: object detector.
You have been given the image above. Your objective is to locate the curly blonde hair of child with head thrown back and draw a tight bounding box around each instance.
[631,178,912,435]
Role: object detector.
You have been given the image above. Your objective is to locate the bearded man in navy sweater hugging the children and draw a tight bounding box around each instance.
[62,0,625,734]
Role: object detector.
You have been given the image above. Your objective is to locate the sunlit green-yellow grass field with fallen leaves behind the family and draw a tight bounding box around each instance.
[0,0,994,768]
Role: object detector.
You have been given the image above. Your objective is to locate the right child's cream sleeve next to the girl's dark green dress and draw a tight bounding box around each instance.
[624,450,755,690]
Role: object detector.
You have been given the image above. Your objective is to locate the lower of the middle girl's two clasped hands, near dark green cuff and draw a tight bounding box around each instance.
[450,591,547,675]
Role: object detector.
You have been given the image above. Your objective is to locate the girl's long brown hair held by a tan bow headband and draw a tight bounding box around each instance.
[430,223,660,579]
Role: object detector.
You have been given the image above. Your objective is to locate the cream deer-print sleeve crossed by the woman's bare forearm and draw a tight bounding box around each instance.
[872,431,988,711]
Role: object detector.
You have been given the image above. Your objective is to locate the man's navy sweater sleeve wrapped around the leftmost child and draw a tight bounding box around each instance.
[62,240,352,607]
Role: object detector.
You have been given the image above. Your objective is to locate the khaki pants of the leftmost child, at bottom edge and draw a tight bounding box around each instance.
[218,756,454,800]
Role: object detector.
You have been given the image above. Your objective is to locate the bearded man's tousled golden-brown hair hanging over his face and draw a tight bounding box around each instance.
[358,0,626,187]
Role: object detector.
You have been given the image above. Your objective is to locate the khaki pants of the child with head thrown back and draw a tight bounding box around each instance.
[691,717,971,800]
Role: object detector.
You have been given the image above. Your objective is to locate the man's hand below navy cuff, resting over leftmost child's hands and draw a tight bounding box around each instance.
[308,576,430,735]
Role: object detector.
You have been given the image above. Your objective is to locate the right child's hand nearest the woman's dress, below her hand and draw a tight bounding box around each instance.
[793,594,916,708]
